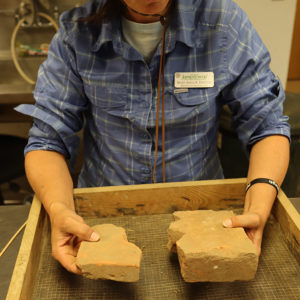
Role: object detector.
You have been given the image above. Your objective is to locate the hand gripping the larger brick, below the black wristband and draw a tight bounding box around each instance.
[223,212,265,255]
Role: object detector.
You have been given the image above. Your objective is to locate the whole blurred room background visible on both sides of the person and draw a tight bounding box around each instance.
[0,0,300,205]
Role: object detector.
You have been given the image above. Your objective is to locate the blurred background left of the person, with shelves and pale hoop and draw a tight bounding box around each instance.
[0,0,86,205]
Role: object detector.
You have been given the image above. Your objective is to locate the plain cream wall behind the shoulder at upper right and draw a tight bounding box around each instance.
[235,0,297,87]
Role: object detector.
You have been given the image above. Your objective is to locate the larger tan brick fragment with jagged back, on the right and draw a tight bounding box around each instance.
[168,210,258,282]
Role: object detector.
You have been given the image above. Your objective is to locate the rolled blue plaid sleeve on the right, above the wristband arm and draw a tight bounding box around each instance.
[222,5,290,155]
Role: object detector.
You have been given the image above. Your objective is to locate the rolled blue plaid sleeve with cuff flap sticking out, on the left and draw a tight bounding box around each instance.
[16,17,87,161]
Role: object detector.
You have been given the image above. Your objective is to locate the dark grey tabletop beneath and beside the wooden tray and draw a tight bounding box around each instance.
[0,197,300,300]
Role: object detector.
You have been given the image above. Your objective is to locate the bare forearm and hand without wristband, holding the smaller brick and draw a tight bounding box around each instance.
[25,150,99,274]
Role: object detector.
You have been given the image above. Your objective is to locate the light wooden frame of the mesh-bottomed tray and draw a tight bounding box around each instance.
[7,178,300,300]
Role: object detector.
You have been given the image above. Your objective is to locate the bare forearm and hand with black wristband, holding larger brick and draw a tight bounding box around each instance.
[227,135,289,255]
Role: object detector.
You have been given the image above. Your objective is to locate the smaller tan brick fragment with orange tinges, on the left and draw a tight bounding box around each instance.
[76,224,142,282]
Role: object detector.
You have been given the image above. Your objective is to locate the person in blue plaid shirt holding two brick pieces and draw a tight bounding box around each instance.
[18,0,290,273]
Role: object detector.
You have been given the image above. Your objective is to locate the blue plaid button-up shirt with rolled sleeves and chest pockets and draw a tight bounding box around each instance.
[17,0,290,187]
